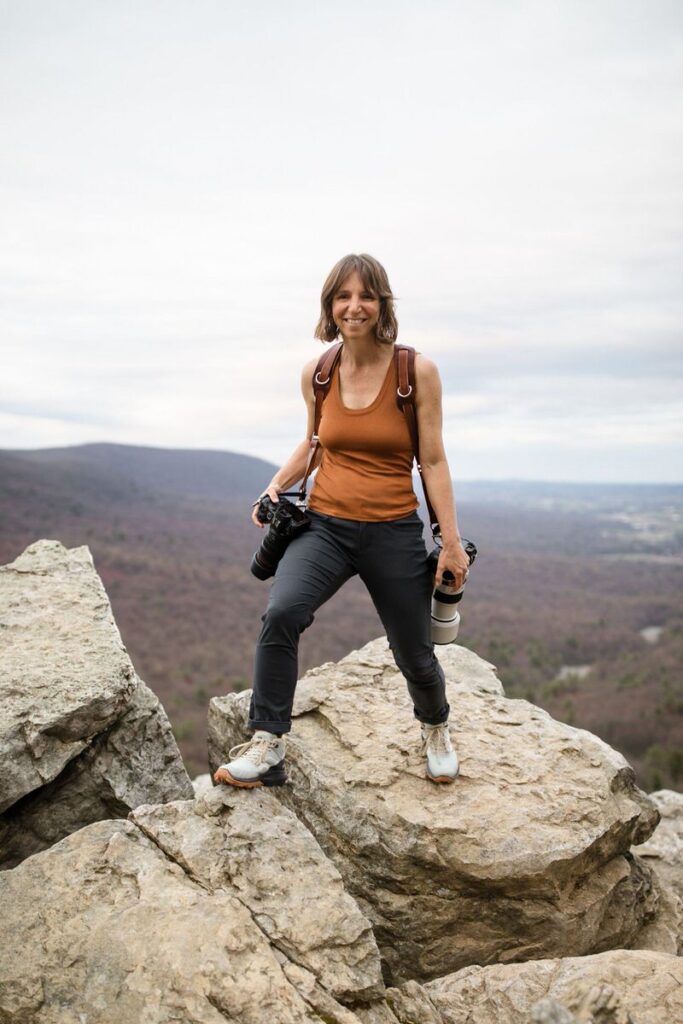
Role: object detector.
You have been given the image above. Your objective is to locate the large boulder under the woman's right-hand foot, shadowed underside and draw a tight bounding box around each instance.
[209,639,659,984]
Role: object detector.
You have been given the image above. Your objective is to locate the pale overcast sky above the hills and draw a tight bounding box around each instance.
[0,0,683,484]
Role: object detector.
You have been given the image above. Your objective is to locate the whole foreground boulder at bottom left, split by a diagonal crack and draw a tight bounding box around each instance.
[0,788,384,1024]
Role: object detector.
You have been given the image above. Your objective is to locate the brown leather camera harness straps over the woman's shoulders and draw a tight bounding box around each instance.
[299,341,440,539]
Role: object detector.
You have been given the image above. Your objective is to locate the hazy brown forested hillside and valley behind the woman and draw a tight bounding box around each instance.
[0,444,683,791]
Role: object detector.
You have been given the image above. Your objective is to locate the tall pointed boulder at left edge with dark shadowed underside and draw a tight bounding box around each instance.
[0,541,193,868]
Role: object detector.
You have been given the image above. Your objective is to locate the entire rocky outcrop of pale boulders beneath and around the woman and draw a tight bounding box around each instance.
[0,542,683,1024]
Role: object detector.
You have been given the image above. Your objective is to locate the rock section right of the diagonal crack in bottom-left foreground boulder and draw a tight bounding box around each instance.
[130,786,384,1002]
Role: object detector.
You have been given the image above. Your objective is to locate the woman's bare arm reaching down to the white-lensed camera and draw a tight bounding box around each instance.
[415,353,469,587]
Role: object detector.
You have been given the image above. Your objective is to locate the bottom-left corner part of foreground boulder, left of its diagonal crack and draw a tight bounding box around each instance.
[0,821,352,1024]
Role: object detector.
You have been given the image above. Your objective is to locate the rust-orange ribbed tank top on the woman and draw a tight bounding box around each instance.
[308,358,418,522]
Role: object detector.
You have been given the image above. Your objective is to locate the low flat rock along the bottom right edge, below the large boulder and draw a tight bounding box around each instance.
[366,949,683,1024]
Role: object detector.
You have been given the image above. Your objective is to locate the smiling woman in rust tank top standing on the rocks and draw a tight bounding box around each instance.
[214,254,469,787]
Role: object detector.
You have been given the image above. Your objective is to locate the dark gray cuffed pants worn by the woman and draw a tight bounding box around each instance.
[249,509,450,732]
